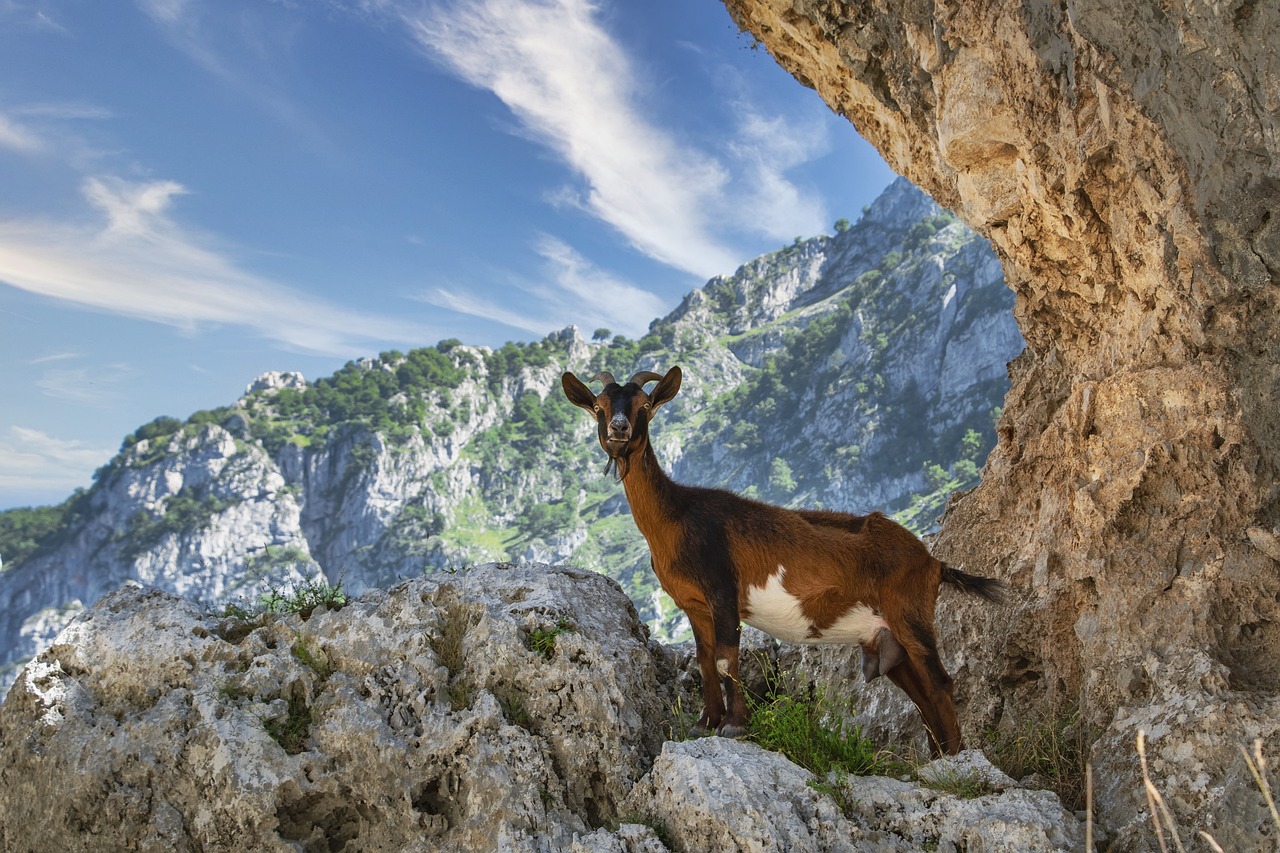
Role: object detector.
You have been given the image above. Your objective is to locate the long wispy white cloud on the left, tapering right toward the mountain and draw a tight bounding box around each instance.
[0,177,429,355]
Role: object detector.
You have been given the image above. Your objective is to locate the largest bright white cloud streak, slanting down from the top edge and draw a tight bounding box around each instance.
[375,0,820,277]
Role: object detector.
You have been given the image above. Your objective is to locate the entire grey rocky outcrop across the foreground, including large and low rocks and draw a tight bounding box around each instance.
[0,564,1084,853]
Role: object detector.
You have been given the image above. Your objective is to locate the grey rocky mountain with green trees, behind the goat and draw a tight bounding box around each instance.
[0,181,1023,686]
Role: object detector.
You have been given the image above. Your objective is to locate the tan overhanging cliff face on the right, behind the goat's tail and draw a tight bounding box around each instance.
[726,0,1280,849]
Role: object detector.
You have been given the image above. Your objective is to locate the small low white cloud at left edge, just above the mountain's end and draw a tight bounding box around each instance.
[0,427,115,496]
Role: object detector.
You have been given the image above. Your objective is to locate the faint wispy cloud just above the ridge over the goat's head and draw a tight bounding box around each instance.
[420,236,666,334]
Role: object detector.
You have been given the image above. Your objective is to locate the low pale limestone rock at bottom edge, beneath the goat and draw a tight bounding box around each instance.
[626,738,1084,853]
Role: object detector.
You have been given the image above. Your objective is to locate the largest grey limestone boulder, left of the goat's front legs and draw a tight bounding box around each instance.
[0,566,667,850]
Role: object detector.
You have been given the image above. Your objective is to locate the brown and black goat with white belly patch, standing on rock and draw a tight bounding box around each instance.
[561,366,1005,757]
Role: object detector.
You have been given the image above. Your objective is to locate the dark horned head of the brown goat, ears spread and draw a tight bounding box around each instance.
[561,368,681,480]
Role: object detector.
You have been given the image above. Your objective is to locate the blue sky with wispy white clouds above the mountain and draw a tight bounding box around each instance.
[0,0,893,510]
